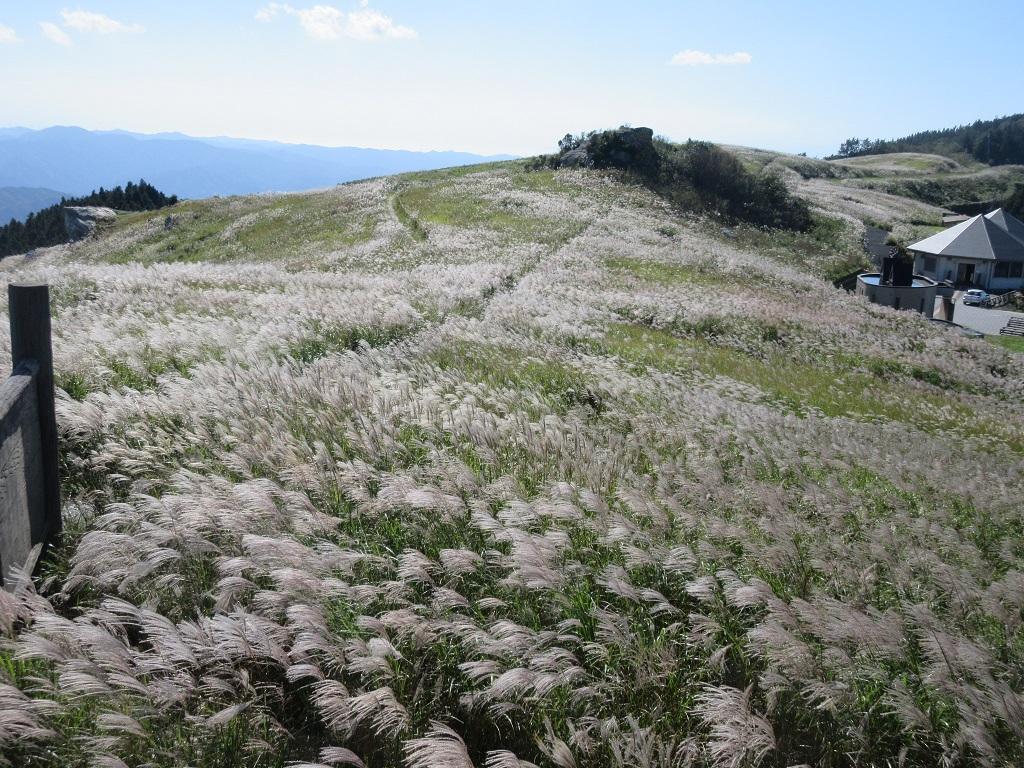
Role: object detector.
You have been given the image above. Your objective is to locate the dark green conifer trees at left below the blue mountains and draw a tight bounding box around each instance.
[0,179,178,258]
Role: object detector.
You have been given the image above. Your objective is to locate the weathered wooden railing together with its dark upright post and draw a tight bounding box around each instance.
[0,284,60,584]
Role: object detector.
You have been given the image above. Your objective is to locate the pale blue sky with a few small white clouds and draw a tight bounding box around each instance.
[0,0,1024,155]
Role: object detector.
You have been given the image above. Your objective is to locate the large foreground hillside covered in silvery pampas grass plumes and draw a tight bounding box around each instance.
[0,159,1024,768]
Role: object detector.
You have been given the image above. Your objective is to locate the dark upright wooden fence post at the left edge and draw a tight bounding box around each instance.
[7,283,62,544]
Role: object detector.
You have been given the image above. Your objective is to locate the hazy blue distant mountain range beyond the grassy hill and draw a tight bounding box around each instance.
[0,127,513,214]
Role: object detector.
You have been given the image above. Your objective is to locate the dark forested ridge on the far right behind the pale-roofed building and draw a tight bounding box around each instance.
[836,115,1024,165]
